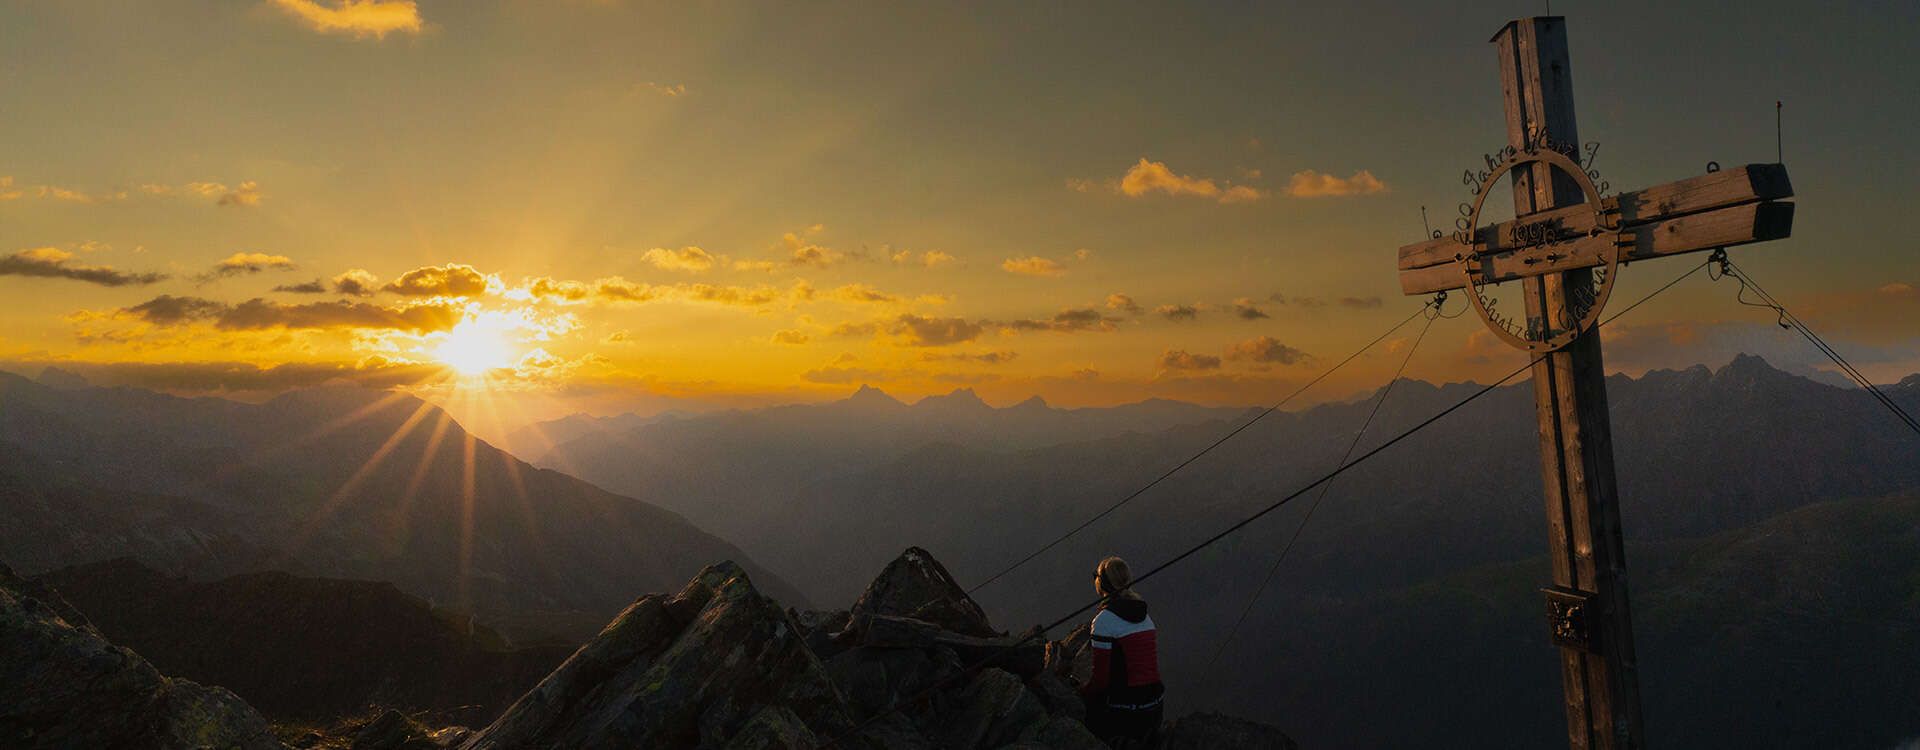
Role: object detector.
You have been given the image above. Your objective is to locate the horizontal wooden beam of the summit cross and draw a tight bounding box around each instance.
[1400,165,1793,293]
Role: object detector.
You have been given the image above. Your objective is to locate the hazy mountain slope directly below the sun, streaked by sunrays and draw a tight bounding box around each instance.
[0,376,797,627]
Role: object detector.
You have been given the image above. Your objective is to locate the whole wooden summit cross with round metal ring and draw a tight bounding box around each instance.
[1400,17,1793,748]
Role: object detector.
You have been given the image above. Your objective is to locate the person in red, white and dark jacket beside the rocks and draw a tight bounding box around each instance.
[1079,558,1162,744]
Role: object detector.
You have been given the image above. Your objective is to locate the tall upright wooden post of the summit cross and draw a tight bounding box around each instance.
[1494,17,1644,750]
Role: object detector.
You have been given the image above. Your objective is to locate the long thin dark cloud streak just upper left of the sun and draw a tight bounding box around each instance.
[121,293,465,334]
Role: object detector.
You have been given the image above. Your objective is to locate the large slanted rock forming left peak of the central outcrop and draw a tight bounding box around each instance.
[463,562,852,750]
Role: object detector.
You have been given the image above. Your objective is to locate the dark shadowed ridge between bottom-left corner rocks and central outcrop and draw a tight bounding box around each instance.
[36,558,574,721]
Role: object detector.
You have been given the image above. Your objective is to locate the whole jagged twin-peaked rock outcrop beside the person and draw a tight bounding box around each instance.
[463,549,1290,750]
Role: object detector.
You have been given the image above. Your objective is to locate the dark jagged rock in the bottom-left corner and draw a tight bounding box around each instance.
[0,566,282,750]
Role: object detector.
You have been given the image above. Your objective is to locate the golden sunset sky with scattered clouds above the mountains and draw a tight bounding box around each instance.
[0,0,1920,441]
